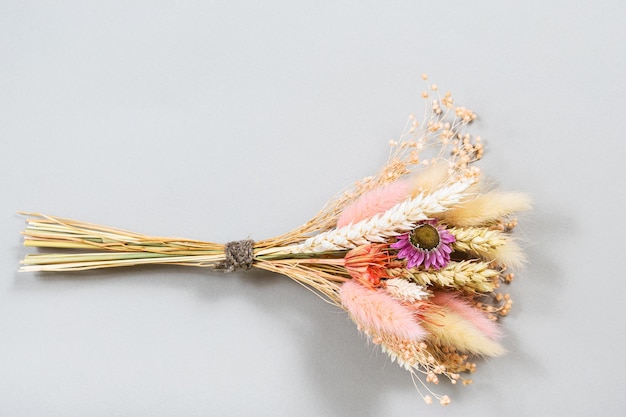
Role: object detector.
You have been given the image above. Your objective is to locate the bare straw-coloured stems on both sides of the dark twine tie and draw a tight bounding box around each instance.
[20,213,350,302]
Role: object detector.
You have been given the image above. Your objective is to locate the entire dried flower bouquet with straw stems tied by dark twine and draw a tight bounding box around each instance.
[20,75,530,405]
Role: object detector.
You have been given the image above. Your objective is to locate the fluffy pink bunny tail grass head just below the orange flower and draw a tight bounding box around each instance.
[339,280,427,340]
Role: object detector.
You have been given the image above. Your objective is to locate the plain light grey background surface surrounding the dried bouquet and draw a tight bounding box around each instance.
[0,0,626,417]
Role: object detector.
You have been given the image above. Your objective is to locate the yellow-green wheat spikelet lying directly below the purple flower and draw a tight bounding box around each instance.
[387,261,499,293]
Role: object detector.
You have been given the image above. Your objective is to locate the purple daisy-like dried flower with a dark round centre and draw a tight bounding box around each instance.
[389,220,456,269]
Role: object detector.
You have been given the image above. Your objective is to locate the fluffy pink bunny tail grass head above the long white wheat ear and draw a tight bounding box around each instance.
[337,180,411,227]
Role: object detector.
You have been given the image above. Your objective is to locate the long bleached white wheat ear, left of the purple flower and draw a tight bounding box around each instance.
[289,180,472,253]
